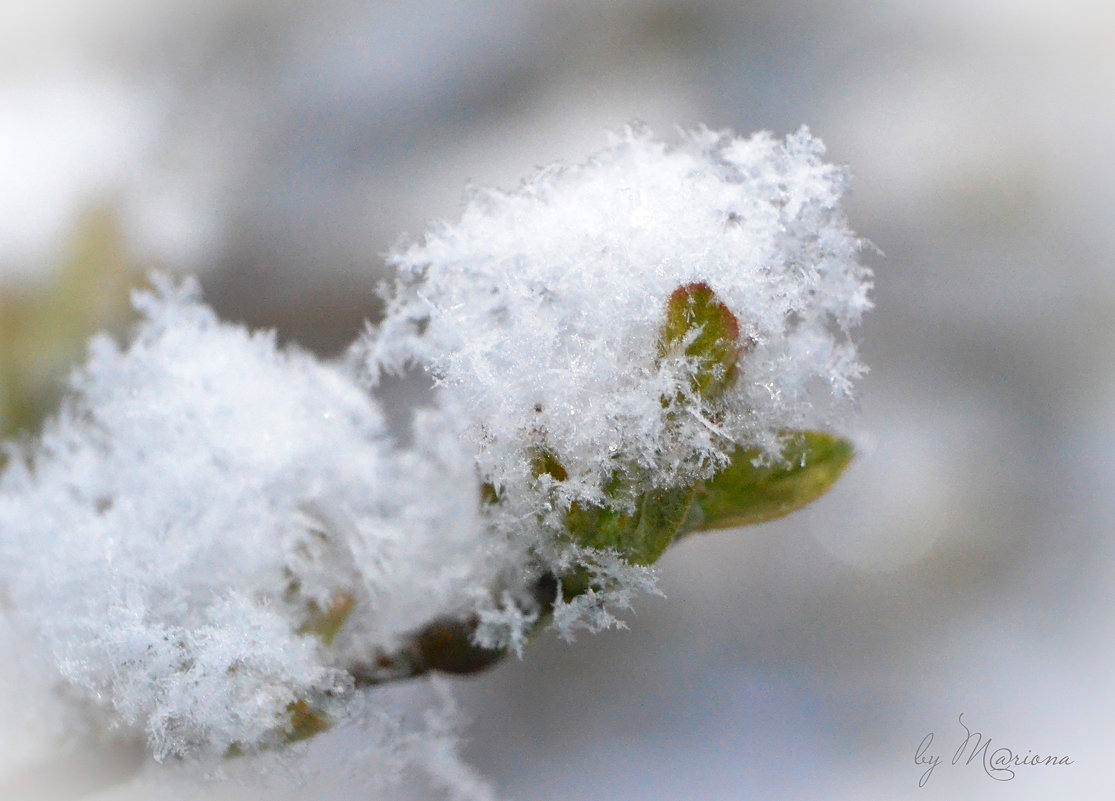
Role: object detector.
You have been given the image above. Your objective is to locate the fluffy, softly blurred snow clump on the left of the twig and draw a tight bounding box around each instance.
[0,282,497,757]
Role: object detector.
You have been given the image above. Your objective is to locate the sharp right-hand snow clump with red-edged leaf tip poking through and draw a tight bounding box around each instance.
[366,128,870,638]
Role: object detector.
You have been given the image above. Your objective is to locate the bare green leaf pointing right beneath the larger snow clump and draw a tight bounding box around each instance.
[688,432,853,531]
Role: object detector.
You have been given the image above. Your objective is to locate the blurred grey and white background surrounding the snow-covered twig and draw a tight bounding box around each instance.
[0,0,1115,801]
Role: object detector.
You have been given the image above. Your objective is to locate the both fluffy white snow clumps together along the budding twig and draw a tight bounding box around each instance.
[0,123,870,756]
